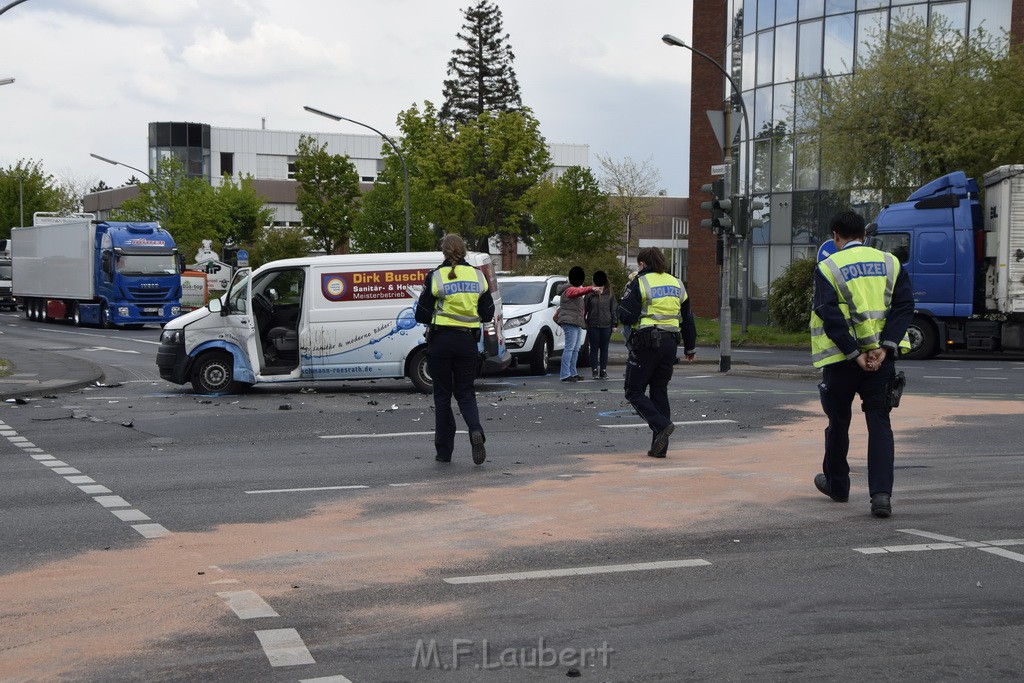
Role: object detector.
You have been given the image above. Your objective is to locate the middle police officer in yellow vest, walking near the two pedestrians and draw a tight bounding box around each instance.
[618,247,697,458]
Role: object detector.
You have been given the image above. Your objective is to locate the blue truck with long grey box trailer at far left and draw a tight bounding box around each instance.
[11,213,181,328]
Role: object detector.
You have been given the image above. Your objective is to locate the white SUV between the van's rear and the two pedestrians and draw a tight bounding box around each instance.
[498,275,589,375]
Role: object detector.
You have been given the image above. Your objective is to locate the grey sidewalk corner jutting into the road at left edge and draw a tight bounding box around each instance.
[0,345,103,400]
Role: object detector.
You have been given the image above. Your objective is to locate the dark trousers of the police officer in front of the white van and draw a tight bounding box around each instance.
[427,326,483,458]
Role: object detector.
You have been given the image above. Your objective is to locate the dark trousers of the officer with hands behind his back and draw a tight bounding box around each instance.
[818,358,896,497]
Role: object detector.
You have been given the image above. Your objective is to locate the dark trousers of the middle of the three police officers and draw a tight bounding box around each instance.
[624,333,679,448]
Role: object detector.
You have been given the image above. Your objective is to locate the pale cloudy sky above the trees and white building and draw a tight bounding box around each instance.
[0,0,692,196]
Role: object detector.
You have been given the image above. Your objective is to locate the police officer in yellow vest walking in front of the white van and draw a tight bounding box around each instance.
[416,234,495,465]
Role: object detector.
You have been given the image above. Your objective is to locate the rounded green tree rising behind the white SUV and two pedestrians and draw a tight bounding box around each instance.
[534,166,623,258]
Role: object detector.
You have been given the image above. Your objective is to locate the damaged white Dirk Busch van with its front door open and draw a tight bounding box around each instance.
[157,252,511,393]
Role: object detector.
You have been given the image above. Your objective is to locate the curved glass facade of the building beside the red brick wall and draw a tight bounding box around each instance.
[725,0,1014,323]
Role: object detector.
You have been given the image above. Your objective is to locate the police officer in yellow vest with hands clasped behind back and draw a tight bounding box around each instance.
[811,211,914,517]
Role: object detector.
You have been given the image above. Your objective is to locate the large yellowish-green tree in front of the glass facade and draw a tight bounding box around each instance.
[798,15,1024,203]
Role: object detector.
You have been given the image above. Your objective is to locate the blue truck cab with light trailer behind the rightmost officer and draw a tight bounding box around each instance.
[868,164,1024,359]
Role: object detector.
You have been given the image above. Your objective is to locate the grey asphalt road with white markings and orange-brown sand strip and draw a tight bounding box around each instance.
[0,316,1024,683]
